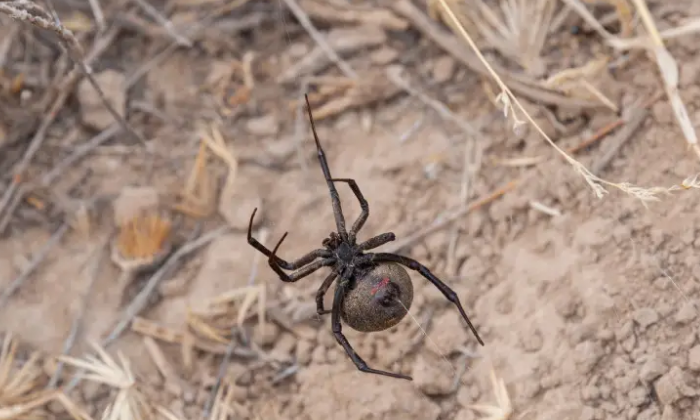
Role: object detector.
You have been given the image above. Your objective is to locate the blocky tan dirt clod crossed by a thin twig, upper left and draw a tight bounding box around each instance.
[78,70,126,130]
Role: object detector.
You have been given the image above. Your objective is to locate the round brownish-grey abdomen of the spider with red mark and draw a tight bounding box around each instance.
[340,263,413,332]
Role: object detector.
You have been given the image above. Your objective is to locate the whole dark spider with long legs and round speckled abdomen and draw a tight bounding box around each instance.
[248,95,484,380]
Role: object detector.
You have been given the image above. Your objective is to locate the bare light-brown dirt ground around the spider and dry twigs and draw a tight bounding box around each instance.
[0,1,700,420]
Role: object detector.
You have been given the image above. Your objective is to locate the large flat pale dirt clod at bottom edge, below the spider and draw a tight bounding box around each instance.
[297,364,440,420]
